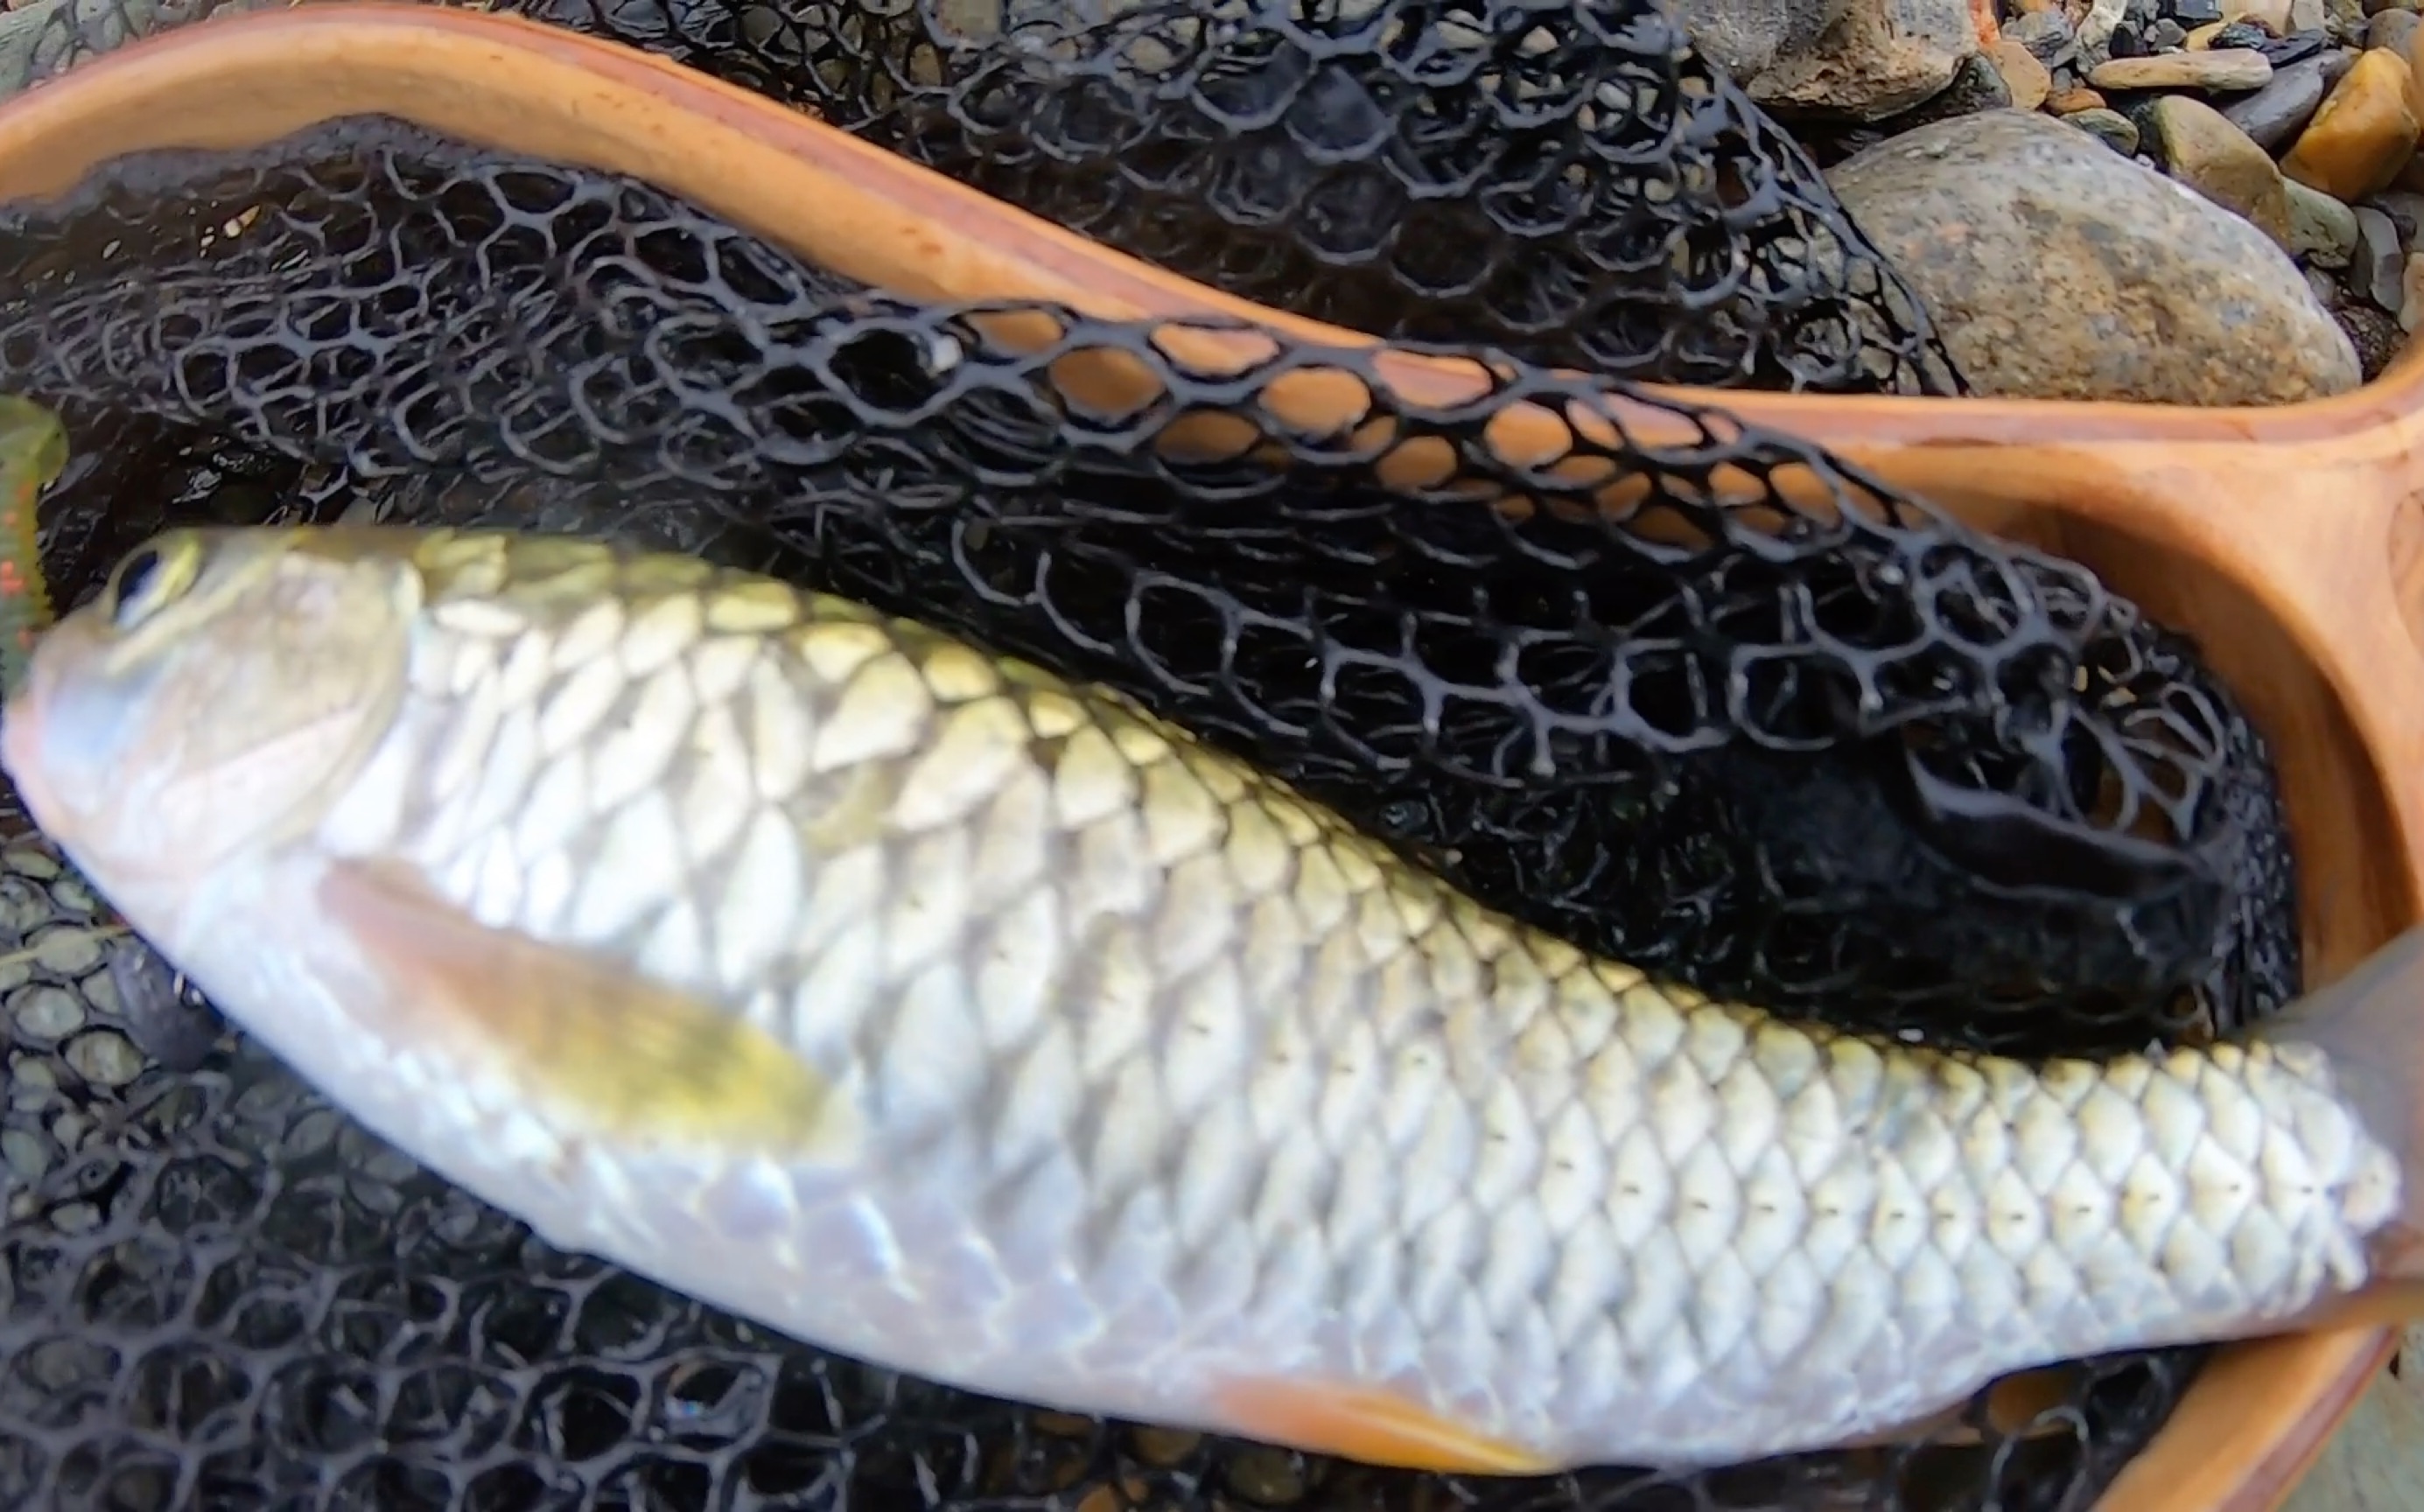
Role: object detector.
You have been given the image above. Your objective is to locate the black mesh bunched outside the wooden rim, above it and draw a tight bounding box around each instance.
[0,0,1964,393]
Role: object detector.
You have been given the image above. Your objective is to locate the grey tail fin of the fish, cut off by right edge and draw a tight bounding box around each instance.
[2254,923,2424,1323]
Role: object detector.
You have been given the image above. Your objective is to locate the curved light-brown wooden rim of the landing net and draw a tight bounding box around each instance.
[0,0,2424,1512]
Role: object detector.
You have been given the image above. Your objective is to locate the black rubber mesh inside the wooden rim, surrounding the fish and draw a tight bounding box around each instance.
[0,7,2298,1512]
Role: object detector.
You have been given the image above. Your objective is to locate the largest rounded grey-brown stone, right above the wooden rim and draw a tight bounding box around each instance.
[1828,111,2358,404]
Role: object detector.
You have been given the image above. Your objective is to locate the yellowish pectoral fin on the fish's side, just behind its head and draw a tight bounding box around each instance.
[320,863,849,1153]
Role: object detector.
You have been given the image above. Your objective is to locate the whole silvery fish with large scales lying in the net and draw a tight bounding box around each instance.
[0,523,2424,1475]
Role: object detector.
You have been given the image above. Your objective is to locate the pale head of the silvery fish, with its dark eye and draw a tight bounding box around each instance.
[0,528,424,915]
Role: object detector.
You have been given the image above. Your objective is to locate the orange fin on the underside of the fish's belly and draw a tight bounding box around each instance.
[1215,1379,1564,1475]
